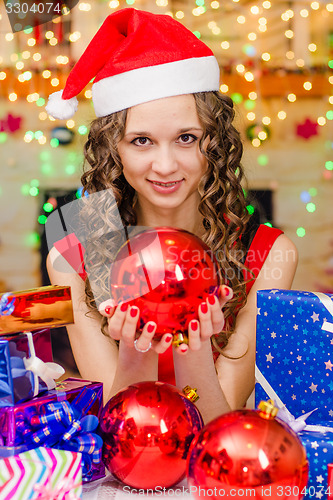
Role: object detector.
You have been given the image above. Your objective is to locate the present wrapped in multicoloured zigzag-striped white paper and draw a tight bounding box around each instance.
[0,448,82,500]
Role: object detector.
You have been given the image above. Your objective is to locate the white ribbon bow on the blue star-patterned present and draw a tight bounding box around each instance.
[255,365,333,433]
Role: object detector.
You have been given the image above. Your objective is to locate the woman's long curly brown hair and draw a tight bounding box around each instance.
[81,92,250,351]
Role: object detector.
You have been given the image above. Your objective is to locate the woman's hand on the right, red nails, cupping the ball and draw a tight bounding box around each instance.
[175,285,233,354]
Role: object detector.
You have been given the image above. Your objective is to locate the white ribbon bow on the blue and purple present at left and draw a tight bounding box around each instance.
[23,332,65,396]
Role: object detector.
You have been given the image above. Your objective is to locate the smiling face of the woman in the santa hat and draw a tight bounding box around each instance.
[118,94,208,217]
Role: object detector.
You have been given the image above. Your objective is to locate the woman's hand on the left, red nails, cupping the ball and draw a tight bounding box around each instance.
[99,300,173,354]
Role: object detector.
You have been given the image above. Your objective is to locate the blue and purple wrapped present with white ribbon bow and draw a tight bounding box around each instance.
[0,328,65,407]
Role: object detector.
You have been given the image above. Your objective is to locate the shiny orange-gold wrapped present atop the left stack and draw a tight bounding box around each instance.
[0,285,74,335]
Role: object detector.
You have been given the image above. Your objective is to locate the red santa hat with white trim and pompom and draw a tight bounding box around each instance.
[46,8,220,119]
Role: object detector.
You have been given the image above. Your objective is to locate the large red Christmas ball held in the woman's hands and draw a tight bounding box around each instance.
[110,227,220,338]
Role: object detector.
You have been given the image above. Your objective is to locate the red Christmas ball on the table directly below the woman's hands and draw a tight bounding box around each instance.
[100,382,203,489]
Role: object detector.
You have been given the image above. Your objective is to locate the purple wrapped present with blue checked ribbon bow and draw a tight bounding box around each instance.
[0,378,105,481]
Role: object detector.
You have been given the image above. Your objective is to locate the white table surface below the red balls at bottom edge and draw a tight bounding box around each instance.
[82,474,193,500]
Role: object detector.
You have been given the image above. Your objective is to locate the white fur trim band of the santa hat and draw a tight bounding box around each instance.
[92,56,220,117]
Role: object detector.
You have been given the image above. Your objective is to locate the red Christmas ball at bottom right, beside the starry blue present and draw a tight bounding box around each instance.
[187,410,308,500]
